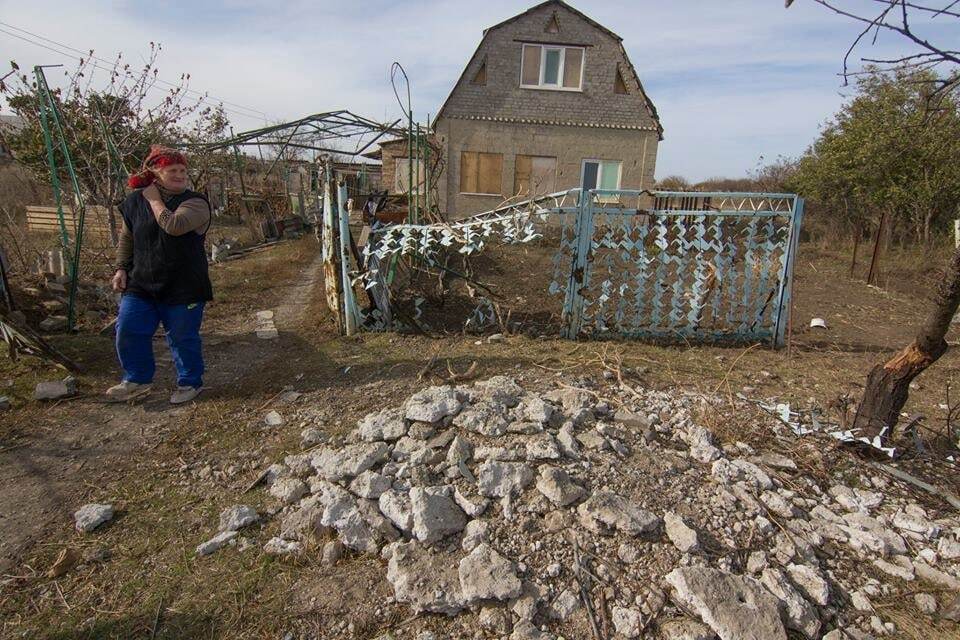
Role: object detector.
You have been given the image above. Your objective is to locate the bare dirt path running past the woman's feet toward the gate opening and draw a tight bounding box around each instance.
[0,244,322,573]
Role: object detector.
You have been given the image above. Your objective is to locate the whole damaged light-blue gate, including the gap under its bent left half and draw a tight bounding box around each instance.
[341,189,803,347]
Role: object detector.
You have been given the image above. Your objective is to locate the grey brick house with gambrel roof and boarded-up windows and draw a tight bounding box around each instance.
[382,0,663,219]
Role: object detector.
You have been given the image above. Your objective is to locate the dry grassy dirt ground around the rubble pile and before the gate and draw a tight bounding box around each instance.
[0,237,960,638]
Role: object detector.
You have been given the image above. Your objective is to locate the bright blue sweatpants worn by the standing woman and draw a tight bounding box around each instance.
[117,294,204,387]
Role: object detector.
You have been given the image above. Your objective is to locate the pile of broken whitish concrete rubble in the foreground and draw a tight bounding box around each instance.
[204,376,960,640]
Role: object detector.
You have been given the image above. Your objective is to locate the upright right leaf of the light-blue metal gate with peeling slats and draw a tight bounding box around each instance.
[550,190,803,347]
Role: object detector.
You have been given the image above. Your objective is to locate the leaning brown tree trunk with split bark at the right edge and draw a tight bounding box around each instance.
[853,249,960,442]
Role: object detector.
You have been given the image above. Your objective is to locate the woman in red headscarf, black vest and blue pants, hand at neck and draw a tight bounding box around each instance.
[106,145,213,404]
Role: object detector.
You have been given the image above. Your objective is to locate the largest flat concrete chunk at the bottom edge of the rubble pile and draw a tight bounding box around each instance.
[666,567,787,640]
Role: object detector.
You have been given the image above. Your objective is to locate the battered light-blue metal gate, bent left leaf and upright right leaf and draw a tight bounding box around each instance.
[336,189,803,347]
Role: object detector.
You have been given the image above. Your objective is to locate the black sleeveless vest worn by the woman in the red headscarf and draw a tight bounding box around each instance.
[120,189,213,304]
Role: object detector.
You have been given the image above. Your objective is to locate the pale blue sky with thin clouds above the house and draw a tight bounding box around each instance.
[0,0,960,180]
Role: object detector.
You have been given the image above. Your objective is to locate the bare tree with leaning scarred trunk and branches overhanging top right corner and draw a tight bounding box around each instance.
[785,0,960,441]
